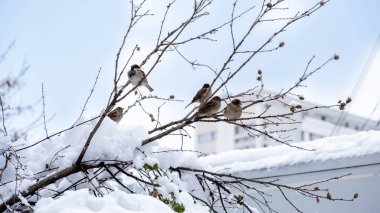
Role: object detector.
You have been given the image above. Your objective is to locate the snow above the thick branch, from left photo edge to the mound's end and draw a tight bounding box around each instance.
[0,117,147,195]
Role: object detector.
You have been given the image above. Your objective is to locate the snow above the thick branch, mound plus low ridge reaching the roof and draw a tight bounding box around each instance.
[8,117,202,173]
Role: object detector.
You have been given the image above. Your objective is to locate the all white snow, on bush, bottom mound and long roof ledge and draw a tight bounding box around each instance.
[4,118,380,213]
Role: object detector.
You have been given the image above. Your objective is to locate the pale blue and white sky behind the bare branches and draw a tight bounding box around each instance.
[0,0,380,147]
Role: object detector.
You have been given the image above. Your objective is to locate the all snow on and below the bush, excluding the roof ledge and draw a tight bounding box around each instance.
[0,117,208,213]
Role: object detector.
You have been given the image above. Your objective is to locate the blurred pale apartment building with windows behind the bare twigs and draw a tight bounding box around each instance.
[194,92,377,154]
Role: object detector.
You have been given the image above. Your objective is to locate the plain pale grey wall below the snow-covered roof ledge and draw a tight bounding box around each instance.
[232,154,380,213]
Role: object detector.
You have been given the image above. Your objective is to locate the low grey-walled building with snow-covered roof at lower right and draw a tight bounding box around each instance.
[204,131,380,213]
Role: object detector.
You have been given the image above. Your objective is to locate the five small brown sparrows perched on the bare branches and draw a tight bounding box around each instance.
[107,64,242,123]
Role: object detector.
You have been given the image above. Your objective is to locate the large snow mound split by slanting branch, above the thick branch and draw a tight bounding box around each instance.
[14,117,147,173]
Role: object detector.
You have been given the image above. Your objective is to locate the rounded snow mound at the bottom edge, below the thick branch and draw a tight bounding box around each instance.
[34,189,173,213]
